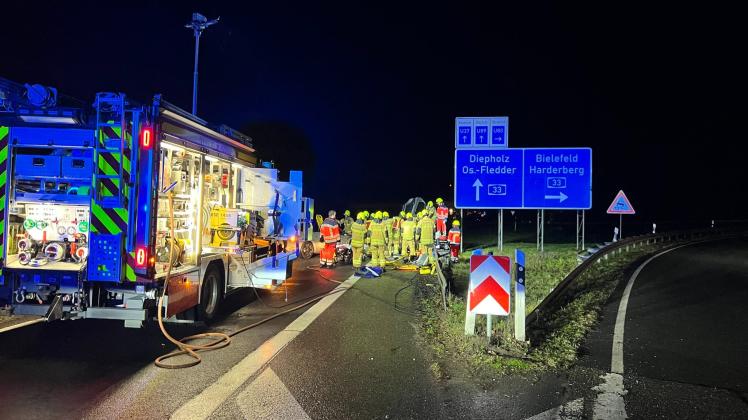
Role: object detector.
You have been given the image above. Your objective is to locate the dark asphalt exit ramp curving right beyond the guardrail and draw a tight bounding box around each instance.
[579,239,748,419]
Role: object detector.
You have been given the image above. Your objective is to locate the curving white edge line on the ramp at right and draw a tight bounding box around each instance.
[592,244,693,419]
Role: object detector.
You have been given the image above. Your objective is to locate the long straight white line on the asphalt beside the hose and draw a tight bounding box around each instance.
[171,276,359,419]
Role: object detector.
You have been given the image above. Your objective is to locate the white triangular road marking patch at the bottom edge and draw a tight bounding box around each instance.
[236,368,310,420]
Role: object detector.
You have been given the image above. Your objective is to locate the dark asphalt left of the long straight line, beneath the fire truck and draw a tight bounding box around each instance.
[0,259,344,419]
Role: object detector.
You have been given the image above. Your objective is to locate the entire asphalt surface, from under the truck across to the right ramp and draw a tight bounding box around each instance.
[0,240,748,419]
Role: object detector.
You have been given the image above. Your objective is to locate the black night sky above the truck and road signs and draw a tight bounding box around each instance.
[0,1,748,226]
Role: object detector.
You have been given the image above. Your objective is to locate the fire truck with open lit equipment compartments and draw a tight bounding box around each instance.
[0,79,313,327]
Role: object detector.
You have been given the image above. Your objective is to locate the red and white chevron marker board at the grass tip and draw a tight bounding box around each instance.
[468,255,511,315]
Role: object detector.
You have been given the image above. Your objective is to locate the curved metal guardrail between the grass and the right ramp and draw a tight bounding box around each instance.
[526,229,746,328]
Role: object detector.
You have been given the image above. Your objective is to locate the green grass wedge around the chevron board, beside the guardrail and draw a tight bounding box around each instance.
[421,243,655,380]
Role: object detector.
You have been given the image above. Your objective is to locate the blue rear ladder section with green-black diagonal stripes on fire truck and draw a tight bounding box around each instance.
[88,92,140,282]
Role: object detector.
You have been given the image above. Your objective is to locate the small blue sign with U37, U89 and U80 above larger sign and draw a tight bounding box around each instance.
[455,117,509,149]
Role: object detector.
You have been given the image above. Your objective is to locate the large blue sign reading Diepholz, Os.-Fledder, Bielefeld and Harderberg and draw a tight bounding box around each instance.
[454,148,592,209]
